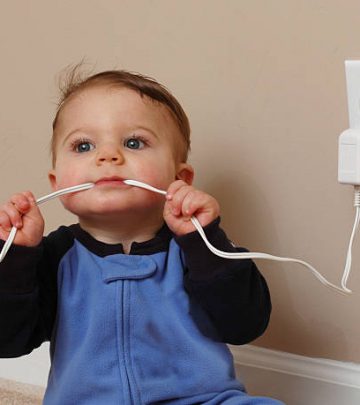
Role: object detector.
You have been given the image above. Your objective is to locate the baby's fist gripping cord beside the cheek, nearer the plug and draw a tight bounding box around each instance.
[164,180,220,236]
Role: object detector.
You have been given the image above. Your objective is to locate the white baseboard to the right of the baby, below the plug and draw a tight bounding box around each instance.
[230,345,360,405]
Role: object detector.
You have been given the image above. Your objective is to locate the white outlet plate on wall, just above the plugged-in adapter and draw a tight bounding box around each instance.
[345,60,360,129]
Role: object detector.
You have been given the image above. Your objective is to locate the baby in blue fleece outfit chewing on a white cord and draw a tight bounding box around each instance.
[0,71,280,405]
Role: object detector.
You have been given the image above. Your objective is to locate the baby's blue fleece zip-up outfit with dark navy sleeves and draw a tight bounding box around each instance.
[0,220,280,405]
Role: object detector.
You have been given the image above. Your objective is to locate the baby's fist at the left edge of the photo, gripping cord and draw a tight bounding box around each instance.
[0,191,44,246]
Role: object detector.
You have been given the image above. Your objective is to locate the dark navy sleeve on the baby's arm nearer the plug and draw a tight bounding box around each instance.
[176,218,271,344]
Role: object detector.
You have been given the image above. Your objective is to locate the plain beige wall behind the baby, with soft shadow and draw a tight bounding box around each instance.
[0,0,360,363]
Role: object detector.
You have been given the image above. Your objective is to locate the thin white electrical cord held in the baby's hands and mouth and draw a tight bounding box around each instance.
[0,180,360,295]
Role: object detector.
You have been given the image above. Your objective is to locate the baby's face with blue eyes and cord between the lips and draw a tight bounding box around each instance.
[49,85,191,217]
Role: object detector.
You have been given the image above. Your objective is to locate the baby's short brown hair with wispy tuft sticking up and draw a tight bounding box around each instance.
[51,63,190,166]
